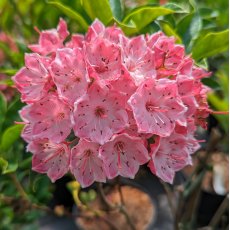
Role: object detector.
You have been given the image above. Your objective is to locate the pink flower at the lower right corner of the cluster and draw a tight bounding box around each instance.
[148,133,192,184]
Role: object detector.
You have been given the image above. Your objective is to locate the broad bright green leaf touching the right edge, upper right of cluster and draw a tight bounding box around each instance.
[192,30,229,60]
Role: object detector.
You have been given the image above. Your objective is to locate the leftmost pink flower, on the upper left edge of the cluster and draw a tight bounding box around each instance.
[13,54,52,103]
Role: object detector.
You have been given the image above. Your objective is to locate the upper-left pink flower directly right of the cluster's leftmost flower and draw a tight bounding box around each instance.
[51,48,88,105]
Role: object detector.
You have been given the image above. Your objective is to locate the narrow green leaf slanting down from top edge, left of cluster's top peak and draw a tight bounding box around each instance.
[48,1,88,31]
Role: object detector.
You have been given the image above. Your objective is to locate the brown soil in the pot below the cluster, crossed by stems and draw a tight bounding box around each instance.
[77,186,156,230]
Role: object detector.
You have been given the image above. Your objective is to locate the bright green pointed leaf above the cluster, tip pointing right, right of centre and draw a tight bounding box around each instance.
[122,6,174,31]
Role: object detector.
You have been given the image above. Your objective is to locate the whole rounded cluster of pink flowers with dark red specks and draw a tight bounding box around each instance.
[13,19,210,187]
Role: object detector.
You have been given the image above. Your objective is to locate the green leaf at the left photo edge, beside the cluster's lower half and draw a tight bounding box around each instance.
[0,125,24,151]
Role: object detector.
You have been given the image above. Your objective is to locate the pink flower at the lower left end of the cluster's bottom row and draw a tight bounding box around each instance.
[27,139,70,182]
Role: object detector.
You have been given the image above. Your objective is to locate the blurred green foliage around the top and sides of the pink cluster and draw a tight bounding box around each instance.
[0,0,229,229]
